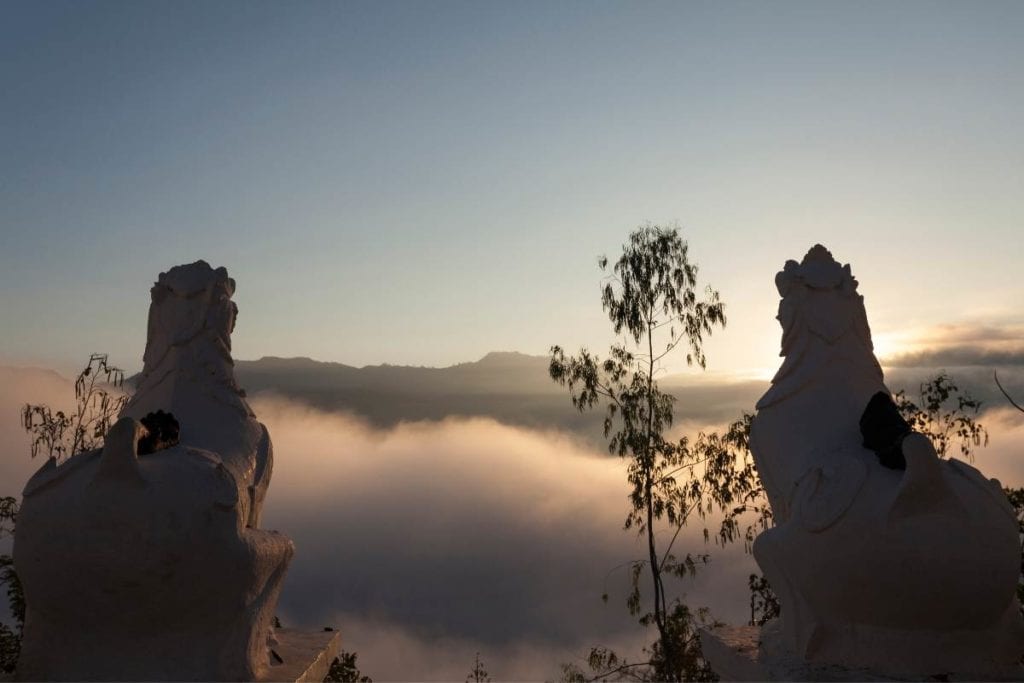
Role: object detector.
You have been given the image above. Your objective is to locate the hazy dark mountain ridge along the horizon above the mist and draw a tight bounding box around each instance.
[14,352,1024,445]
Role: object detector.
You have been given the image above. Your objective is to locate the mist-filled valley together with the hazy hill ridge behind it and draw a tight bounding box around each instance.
[0,353,1024,680]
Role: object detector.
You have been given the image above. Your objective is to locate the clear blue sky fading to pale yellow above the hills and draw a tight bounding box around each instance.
[0,1,1024,371]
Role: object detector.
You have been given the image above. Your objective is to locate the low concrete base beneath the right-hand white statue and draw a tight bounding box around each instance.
[700,626,1024,682]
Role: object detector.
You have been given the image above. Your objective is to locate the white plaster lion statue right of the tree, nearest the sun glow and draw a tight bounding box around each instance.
[751,245,1024,678]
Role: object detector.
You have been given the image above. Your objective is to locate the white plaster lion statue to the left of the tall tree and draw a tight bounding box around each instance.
[14,261,294,680]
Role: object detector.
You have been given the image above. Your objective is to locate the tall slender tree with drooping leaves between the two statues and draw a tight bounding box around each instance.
[549,224,732,681]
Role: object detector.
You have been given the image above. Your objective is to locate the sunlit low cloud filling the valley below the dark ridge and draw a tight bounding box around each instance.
[0,362,1024,681]
